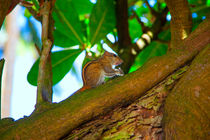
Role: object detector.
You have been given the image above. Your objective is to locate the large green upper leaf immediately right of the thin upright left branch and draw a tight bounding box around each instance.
[53,0,84,47]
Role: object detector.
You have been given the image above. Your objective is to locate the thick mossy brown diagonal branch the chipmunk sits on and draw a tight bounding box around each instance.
[0,19,210,140]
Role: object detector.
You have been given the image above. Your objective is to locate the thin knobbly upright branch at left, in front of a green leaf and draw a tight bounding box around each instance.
[37,1,53,105]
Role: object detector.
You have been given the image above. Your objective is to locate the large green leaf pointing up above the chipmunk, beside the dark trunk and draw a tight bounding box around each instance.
[89,0,116,46]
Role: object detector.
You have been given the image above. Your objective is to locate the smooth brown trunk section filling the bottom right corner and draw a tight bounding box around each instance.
[164,44,210,140]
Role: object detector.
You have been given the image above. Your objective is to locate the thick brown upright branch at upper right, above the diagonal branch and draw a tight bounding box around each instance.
[166,0,192,48]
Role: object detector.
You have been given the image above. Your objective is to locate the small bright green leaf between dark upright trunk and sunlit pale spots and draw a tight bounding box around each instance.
[128,18,143,43]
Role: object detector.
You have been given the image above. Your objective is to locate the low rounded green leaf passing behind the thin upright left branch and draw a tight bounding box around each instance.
[27,49,82,86]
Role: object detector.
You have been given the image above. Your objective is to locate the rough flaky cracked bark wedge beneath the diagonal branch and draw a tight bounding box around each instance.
[63,66,188,140]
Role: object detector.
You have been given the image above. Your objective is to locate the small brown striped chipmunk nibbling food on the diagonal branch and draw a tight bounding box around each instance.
[76,51,124,93]
